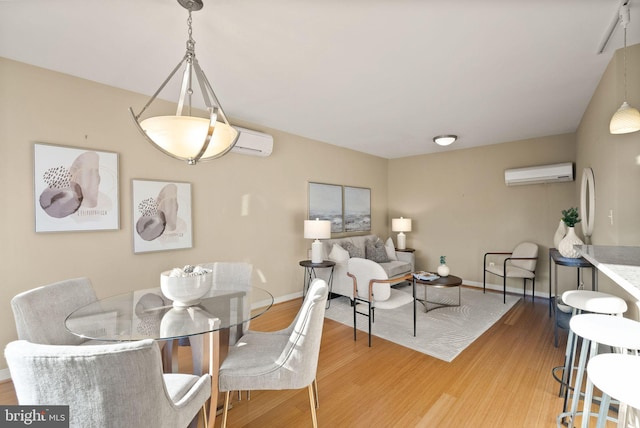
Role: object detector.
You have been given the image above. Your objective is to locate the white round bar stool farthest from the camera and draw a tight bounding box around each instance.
[552,290,627,413]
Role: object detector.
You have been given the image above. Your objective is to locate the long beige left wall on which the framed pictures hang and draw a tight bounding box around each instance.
[0,58,388,368]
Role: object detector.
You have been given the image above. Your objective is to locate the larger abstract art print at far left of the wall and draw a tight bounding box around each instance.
[33,143,120,232]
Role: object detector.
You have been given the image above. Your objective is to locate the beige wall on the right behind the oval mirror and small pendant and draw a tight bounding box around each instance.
[576,45,640,319]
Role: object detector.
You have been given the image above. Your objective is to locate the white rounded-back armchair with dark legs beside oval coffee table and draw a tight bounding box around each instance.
[347,257,413,346]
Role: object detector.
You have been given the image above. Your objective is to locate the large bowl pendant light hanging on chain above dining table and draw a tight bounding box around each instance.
[129,0,239,165]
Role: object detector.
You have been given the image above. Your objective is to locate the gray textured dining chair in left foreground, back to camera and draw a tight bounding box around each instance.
[5,339,211,428]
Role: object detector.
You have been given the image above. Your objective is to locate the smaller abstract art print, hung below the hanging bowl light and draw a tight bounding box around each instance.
[131,179,193,253]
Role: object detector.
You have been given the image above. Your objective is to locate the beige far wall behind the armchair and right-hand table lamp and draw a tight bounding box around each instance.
[389,134,577,295]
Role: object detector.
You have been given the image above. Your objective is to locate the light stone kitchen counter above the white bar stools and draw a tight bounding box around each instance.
[575,245,640,301]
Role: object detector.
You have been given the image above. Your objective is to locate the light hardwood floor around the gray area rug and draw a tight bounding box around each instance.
[0,290,613,428]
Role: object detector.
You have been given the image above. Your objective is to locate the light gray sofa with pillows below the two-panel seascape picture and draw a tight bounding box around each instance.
[316,235,415,298]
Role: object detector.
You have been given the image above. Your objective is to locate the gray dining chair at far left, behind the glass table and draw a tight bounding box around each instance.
[11,278,97,345]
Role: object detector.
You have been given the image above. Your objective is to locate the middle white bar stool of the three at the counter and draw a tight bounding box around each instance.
[558,314,640,427]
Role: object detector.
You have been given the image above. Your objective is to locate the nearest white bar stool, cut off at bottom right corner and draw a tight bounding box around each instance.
[582,354,640,428]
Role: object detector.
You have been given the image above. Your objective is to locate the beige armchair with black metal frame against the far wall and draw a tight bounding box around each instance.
[482,242,538,303]
